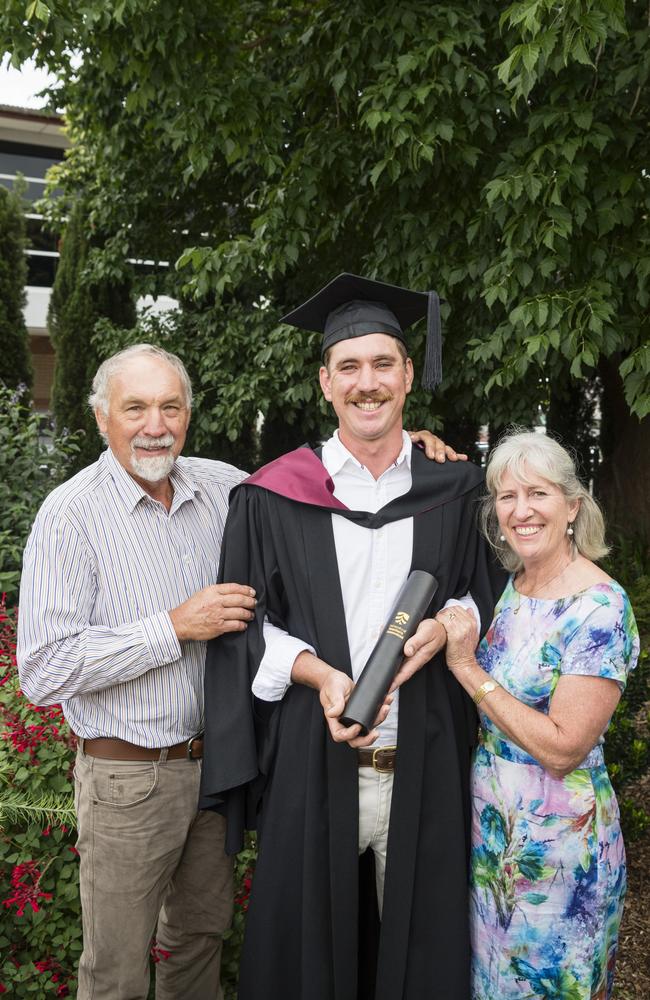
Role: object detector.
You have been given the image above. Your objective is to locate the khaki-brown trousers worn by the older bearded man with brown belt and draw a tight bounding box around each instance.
[75,749,233,1000]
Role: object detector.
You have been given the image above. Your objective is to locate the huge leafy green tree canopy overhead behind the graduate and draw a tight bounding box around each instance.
[0,0,650,525]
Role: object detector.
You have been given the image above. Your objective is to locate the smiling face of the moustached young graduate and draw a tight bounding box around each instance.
[320,333,413,448]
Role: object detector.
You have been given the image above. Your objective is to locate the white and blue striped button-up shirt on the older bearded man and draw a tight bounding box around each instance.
[18,450,246,747]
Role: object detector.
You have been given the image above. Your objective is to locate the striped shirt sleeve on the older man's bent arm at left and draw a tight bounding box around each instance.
[17,515,181,705]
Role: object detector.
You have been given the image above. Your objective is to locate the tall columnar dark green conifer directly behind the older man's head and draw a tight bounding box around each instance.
[48,201,135,472]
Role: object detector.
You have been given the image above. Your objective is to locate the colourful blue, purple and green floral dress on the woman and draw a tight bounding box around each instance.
[471,578,639,1000]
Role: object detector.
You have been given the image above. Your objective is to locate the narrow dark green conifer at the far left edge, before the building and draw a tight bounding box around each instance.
[0,186,34,388]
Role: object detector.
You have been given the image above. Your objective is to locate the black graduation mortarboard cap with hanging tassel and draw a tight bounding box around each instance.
[280,273,442,391]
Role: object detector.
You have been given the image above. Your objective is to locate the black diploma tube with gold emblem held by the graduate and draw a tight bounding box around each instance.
[341,569,438,736]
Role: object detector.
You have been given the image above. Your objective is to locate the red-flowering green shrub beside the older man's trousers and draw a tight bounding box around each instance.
[0,607,81,997]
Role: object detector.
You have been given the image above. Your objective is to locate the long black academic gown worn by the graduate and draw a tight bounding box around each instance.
[201,449,502,1000]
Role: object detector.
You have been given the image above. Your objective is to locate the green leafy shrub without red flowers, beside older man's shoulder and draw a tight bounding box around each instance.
[0,382,78,604]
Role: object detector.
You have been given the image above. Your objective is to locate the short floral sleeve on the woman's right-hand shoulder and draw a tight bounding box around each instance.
[560,589,639,689]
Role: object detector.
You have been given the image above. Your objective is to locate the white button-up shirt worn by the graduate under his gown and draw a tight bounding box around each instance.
[253,431,478,746]
